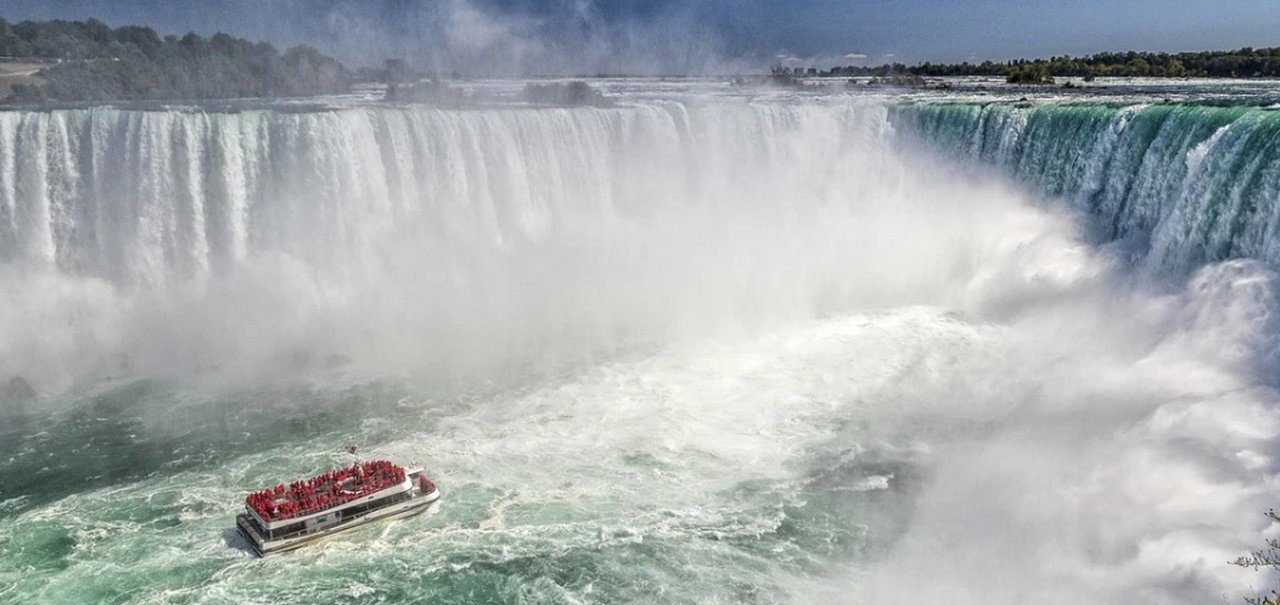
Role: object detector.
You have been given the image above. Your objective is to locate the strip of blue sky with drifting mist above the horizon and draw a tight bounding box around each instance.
[0,0,1280,73]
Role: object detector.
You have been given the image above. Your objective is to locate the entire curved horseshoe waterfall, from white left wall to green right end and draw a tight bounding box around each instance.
[0,101,1280,388]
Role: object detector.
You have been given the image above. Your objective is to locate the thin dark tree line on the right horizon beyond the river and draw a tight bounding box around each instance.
[819,47,1280,81]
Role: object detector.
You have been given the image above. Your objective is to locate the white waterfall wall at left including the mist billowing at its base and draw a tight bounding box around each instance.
[0,101,931,382]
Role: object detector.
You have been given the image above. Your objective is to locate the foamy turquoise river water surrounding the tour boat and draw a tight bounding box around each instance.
[0,318,942,602]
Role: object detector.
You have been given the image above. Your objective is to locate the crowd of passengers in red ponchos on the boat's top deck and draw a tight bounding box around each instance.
[244,460,404,521]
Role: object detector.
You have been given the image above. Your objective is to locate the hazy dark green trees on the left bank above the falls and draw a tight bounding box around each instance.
[0,19,352,102]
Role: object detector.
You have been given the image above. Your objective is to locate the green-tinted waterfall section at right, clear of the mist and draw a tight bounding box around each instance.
[892,104,1280,272]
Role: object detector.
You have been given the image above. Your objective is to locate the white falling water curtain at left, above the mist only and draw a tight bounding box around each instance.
[0,104,901,287]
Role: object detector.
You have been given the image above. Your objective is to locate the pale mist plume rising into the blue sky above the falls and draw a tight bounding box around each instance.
[311,0,744,75]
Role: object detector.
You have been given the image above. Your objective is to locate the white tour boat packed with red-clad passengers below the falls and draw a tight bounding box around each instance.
[236,460,440,556]
